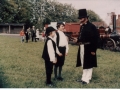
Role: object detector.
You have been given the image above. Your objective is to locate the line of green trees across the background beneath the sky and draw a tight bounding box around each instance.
[0,0,102,29]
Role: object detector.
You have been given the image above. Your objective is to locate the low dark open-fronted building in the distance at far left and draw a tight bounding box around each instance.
[0,23,25,34]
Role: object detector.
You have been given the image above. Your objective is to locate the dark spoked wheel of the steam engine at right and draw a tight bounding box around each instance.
[104,38,116,50]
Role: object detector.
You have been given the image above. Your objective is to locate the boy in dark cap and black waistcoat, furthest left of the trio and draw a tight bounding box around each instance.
[42,27,62,87]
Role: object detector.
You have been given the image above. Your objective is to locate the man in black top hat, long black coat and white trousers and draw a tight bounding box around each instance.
[74,9,99,84]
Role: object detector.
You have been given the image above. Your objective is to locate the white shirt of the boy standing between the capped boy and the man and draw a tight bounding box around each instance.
[54,30,69,53]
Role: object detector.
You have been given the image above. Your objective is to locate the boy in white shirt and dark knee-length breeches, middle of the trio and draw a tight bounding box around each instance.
[54,22,69,81]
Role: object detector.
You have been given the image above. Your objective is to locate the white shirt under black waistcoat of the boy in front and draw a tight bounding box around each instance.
[47,36,60,61]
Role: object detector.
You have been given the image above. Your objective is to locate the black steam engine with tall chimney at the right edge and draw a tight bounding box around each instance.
[99,15,120,51]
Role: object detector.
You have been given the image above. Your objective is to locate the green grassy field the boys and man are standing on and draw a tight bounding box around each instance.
[0,36,120,89]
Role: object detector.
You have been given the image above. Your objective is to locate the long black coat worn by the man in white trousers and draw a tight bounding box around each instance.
[76,21,100,69]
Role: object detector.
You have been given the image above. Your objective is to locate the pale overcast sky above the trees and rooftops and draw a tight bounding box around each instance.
[56,0,120,23]
